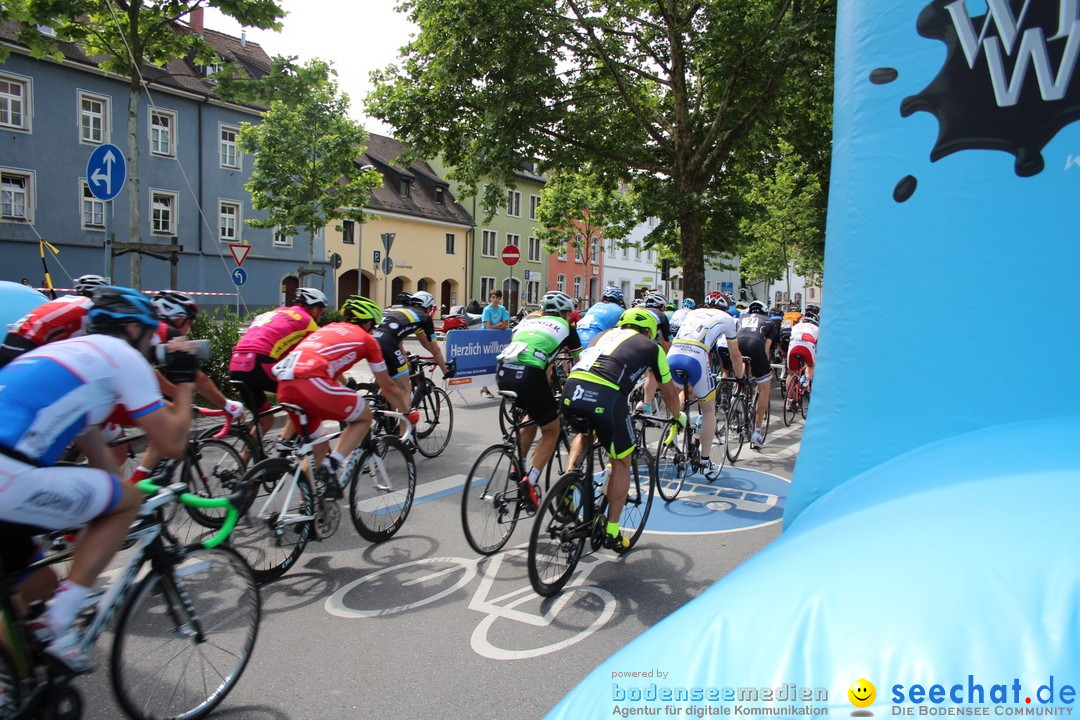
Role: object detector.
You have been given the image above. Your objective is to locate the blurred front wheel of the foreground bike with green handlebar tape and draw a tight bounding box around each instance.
[110,546,261,720]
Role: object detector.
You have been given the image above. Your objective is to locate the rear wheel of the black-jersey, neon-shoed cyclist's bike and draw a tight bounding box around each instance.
[528,471,592,597]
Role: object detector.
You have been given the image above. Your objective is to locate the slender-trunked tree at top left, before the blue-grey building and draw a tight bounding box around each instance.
[9,0,284,287]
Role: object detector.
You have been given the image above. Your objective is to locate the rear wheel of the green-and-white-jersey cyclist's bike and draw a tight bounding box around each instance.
[461,445,522,555]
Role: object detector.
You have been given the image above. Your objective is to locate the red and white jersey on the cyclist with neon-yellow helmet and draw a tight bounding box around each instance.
[273,323,387,381]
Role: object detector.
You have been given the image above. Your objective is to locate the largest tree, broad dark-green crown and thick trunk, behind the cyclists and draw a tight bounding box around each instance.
[368,0,836,297]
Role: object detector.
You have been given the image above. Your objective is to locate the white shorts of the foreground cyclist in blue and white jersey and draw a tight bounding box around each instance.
[0,454,121,530]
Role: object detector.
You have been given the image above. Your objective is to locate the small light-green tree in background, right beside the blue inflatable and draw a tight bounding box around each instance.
[741,140,825,294]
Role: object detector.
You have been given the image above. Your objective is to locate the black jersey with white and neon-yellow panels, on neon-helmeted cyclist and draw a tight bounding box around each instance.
[564,328,672,397]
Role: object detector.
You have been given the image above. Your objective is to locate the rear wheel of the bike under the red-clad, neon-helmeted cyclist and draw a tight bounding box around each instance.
[232,458,314,584]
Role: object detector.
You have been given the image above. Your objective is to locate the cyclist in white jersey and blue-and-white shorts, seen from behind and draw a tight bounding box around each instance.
[667,293,743,480]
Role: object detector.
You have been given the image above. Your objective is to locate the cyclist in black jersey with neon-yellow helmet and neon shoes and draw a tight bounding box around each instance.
[563,308,686,553]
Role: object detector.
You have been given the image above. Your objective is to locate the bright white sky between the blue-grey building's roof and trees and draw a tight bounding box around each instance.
[204,0,416,135]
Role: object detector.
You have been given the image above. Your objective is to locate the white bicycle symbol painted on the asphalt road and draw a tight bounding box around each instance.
[325,547,618,660]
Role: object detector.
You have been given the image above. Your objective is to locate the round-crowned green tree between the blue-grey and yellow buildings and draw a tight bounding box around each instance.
[240,57,382,284]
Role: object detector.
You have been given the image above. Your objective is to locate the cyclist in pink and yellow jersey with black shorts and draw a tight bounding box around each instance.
[229,287,327,437]
